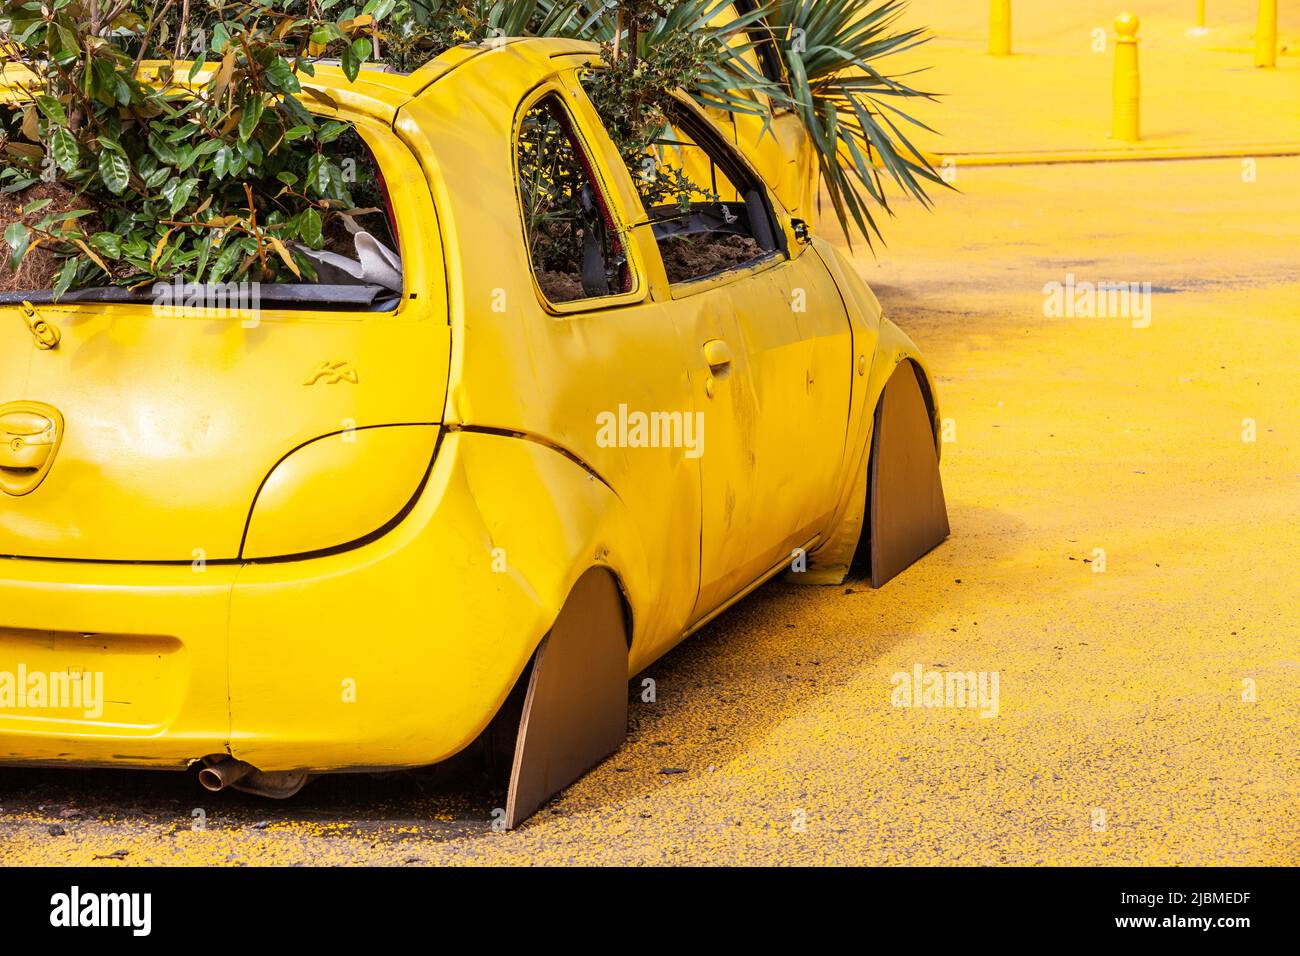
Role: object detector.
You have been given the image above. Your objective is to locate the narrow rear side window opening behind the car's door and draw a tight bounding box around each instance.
[516,94,633,304]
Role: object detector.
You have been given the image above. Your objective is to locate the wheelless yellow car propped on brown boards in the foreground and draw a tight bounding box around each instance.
[0,39,948,825]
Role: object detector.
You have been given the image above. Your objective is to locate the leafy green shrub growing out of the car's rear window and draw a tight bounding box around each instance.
[0,0,382,294]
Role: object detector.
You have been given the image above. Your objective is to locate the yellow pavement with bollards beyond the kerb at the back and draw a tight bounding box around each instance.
[881,0,1300,156]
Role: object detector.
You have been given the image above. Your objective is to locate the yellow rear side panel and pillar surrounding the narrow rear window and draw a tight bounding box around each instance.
[398,44,699,671]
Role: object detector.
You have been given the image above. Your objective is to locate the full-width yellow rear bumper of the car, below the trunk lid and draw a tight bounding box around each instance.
[0,436,556,771]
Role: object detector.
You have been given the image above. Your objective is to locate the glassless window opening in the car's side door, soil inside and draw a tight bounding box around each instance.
[579,75,781,284]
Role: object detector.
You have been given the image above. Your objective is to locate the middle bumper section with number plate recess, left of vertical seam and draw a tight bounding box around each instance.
[0,559,238,767]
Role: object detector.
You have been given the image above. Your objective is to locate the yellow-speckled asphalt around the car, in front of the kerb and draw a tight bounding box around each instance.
[0,149,1300,866]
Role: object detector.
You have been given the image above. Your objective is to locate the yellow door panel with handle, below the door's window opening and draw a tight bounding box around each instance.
[672,240,852,619]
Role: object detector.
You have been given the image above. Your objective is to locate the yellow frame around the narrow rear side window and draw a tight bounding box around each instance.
[510,77,650,316]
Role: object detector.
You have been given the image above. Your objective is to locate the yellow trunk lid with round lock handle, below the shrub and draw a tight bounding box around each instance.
[0,297,450,562]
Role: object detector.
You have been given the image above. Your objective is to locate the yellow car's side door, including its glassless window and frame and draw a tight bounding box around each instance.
[618,103,852,620]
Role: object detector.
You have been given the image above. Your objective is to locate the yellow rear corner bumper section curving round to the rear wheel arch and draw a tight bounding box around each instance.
[229,429,644,771]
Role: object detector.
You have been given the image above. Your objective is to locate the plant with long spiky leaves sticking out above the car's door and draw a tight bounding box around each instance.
[538,0,945,245]
